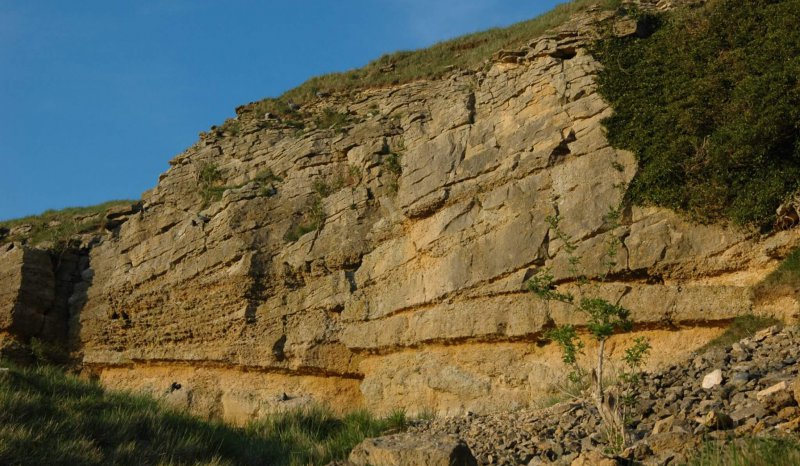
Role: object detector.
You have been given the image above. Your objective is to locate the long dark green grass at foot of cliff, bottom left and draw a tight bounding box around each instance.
[0,364,407,466]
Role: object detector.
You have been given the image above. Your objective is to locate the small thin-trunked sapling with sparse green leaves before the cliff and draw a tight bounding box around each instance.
[527,210,650,447]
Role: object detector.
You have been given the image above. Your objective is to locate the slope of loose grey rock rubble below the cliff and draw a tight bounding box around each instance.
[404,327,800,465]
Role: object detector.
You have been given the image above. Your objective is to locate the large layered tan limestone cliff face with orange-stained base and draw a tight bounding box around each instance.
[0,3,798,421]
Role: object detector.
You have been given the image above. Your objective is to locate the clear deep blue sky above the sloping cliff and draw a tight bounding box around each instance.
[0,0,561,220]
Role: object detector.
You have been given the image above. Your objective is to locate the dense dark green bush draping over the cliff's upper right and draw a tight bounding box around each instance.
[594,0,800,228]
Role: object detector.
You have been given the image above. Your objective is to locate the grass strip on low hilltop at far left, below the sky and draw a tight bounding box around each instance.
[0,200,136,249]
